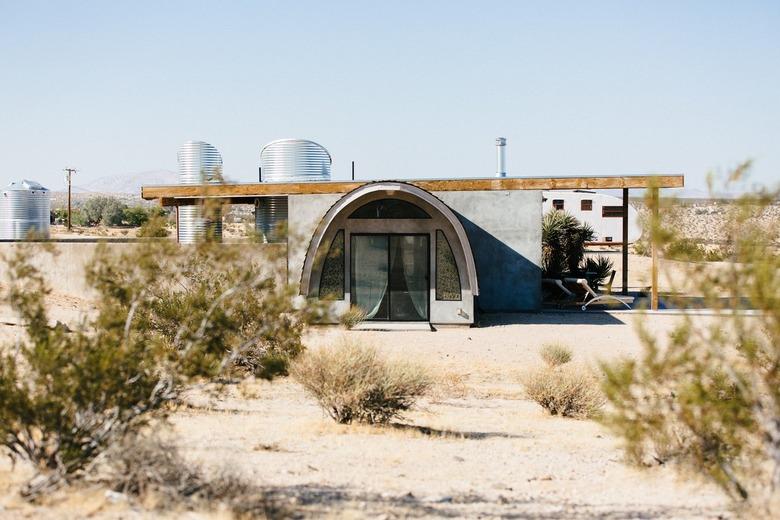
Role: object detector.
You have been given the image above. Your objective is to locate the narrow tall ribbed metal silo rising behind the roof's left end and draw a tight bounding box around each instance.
[176,141,222,244]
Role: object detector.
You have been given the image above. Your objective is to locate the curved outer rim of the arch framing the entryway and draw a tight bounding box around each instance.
[300,181,479,296]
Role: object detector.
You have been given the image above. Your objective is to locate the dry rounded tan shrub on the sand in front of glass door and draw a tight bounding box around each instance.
[291,341,432,424]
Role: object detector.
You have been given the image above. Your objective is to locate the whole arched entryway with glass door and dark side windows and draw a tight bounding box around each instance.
[301,182,479,324]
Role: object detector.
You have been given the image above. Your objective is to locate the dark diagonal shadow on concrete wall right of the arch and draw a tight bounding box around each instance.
[456,212,542,313]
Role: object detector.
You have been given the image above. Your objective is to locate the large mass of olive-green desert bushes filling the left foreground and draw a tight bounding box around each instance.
[0,235,309,496]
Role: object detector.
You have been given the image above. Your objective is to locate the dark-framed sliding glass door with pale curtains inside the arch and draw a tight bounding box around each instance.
[351,234,430,321]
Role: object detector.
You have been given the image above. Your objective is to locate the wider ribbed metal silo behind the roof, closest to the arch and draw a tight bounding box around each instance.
[255,139,333,243]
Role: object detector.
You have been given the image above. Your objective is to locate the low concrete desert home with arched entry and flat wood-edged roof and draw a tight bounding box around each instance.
[141,140,684,325]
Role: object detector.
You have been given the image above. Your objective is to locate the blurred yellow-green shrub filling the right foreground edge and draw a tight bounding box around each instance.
[603,163,780,508]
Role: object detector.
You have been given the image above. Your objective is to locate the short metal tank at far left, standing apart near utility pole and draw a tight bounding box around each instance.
[0,180,51,240]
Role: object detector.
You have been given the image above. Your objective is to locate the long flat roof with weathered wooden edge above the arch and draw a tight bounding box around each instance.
[141,175,685,206]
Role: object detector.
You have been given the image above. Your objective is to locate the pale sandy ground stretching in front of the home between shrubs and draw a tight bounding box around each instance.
[0,309,728,518]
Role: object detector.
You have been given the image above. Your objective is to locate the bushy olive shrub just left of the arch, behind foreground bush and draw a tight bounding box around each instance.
[134,241,320,379]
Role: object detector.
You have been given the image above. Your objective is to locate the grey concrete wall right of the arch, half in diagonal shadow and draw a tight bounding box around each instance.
[434,191,542,312]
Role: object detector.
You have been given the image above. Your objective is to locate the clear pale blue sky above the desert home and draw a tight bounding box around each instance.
[0,0,780,189]
